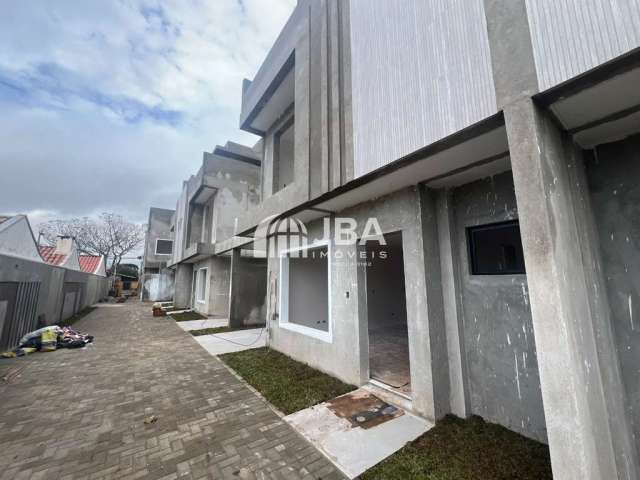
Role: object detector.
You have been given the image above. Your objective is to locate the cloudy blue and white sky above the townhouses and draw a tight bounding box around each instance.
[0,0,296,228]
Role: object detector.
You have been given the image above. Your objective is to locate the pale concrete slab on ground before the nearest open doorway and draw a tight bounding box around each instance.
[284,389,433,478]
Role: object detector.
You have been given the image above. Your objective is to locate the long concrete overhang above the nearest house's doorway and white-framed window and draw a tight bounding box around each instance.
[232,112,511,237]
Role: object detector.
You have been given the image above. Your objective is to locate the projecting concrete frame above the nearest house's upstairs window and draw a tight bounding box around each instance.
[240,1,309,136]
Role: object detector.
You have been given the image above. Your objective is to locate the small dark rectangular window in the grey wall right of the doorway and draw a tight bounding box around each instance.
[467,220,526,275]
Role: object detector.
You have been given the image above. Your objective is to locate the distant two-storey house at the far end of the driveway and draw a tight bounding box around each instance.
[140,207,175,302]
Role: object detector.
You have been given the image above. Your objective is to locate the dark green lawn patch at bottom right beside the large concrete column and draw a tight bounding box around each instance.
[361,415,553,480]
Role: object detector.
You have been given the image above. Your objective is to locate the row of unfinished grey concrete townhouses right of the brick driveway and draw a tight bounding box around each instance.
[142,0,640,480]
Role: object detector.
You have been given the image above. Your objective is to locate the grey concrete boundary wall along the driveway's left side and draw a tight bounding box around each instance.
[0,251,108,348]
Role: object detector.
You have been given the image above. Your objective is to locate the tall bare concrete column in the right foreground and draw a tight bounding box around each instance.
[504,98,638,480]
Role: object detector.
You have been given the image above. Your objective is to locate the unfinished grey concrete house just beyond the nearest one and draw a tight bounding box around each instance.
[170,142,267,325]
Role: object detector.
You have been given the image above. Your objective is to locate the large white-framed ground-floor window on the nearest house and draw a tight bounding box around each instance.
[278,241,333,343]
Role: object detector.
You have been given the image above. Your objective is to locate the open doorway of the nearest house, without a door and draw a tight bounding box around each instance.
[366,232,411,395]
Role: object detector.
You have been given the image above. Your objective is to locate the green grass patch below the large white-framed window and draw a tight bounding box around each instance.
[220,347,356,415]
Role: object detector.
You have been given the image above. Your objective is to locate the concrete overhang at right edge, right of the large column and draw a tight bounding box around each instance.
[534,48,640,148]
